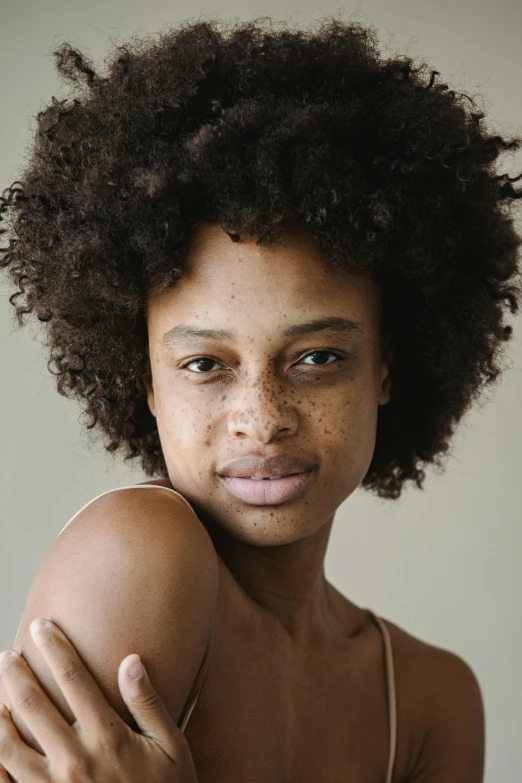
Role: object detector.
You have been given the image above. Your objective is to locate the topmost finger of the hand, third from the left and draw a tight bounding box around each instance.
[30,620,119,731]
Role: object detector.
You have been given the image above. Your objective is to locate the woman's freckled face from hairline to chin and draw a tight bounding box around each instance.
[145,222,390,546]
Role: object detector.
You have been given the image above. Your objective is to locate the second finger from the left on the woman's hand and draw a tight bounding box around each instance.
[0,650,77,758]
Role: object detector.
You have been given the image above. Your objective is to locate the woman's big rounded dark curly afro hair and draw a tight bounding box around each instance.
[0,17,522,499]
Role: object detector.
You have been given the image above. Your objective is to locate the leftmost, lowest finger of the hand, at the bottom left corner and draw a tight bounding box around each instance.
[0,704,49,783]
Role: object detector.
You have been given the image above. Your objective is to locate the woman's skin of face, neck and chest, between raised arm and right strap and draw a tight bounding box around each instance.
[140,216,408,783]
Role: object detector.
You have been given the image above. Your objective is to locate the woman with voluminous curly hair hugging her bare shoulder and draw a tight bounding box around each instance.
[0,13,522,783]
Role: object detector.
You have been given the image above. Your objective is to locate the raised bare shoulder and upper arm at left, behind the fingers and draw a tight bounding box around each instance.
[0,489,218,749]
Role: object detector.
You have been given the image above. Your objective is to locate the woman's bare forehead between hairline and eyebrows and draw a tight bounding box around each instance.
[148,222,380,326]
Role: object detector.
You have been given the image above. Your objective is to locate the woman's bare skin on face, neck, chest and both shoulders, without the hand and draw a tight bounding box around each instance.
[0,217,484,783]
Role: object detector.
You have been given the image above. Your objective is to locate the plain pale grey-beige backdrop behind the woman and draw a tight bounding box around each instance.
[0,0,522,783]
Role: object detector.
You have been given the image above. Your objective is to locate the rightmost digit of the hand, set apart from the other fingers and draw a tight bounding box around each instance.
[118,653,183,756]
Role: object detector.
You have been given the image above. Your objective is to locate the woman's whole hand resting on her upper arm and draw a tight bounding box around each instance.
[0,621,197,783]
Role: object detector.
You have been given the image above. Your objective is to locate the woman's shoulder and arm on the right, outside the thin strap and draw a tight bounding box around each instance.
[382,618,485,783]
